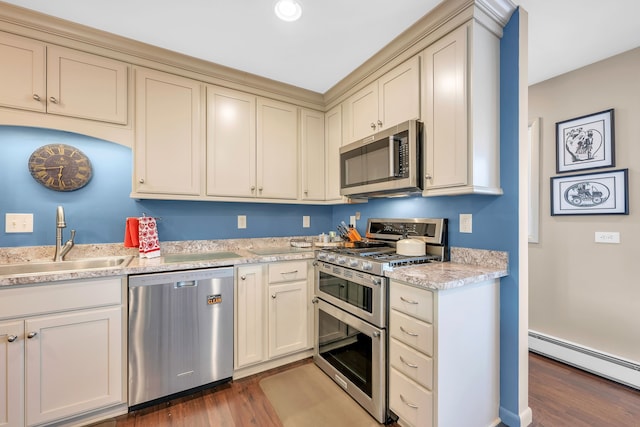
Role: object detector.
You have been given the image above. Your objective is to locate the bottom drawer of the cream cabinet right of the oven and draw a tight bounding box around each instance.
[389,368,433,427]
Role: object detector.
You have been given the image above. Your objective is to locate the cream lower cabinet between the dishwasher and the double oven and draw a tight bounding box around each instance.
[234,260,313,376]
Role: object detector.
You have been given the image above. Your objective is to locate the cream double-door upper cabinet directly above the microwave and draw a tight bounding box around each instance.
[343,56,420,144]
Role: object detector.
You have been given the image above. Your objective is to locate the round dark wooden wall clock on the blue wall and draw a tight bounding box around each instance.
[29,144,93,191]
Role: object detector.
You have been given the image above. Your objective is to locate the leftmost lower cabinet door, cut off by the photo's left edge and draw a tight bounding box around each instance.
[0,321,24,427]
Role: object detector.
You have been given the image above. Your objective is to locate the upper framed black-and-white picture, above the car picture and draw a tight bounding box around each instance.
[556,109,616,173]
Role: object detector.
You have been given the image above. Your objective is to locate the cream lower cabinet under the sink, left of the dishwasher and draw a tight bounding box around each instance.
[0,278,126,427]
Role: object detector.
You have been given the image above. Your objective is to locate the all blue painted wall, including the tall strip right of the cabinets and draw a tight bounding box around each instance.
[0,12,520,427]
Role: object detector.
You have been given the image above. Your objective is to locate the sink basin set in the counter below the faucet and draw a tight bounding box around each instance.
[0,256,133,276]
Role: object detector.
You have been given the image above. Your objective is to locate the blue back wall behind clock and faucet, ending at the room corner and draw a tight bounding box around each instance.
[0,126,332,247]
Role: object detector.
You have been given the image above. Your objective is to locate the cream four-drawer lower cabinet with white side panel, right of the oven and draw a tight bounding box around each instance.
[389,280,500,427]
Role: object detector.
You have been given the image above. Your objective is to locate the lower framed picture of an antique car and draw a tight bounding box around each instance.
[551,169,629,215]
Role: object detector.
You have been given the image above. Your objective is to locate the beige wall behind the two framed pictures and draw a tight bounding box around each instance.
[529,48,640,362]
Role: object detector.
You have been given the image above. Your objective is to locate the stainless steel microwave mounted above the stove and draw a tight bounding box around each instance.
[340,120,423,197]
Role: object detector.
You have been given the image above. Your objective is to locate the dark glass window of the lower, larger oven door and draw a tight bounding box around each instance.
[318,310,373,397]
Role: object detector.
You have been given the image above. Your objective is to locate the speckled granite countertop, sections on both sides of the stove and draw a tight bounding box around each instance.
[0,237,508,290]
